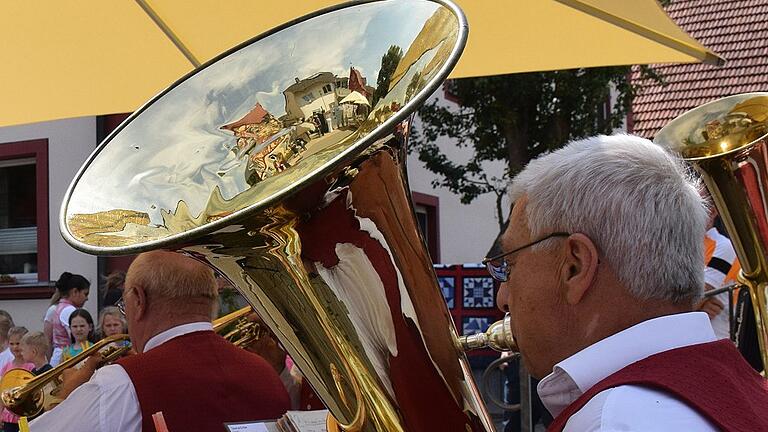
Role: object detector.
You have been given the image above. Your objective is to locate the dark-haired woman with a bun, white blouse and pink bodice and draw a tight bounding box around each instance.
[44,272,91,366]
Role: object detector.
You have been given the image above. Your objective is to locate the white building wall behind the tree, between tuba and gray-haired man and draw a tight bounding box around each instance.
[408,93,509,265]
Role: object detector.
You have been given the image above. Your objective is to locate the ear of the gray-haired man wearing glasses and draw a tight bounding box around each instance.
[561,233,599,305]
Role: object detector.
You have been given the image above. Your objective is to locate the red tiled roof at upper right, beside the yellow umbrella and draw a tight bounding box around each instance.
[632,0,768,138]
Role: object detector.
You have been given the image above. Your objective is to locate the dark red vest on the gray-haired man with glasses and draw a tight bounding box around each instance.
[547,340,768,432]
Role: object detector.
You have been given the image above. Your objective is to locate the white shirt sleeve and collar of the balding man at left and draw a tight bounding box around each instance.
[29,322,213,432]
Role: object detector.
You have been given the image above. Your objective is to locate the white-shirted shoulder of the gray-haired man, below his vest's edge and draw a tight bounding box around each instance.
[565,385,718,431]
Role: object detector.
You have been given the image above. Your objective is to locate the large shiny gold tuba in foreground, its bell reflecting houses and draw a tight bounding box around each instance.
[55,0,516,432]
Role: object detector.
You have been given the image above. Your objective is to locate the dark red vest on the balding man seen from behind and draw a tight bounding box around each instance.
[117,331,290,432]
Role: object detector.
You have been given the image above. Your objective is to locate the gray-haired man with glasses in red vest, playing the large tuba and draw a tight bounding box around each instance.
[492,135,768,431]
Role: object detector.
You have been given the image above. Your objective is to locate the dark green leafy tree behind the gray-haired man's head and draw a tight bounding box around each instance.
[411,66,661,230]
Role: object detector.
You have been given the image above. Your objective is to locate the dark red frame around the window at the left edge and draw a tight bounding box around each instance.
[0,139,53,300]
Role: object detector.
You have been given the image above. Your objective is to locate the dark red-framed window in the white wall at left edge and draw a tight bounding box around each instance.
[0,140,49,298]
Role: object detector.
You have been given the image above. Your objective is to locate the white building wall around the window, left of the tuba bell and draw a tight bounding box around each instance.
[0,117,98,331]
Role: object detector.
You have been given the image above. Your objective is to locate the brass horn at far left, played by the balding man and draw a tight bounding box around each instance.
[0,334,131,417]
